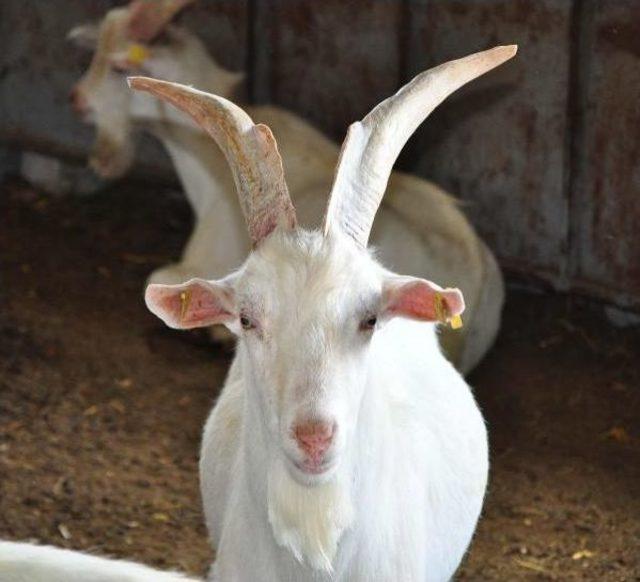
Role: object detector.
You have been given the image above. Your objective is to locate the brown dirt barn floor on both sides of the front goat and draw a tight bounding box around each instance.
[0,180,640,582]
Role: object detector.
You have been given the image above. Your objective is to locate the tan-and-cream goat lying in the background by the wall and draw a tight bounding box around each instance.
[70,0,504,373]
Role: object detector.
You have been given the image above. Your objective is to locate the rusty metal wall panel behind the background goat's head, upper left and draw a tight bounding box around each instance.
[0,0,247,167]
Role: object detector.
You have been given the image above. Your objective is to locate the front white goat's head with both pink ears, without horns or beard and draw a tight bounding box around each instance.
[146,229,464,486]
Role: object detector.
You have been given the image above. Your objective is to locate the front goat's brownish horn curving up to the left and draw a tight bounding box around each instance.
[129,77,296,246]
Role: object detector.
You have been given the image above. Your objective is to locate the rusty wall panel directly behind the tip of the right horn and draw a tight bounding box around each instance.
[409,0,572,286]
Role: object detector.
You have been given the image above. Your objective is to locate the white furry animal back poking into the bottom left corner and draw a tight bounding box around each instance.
[0,541,197,582]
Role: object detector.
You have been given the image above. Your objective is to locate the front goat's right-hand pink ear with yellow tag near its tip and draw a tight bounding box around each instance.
[383,277,464,324]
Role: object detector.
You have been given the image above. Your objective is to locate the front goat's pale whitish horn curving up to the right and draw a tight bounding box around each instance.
[324,45,518,247]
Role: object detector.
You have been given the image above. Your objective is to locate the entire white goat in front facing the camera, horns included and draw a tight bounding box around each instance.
[0,47,515,582]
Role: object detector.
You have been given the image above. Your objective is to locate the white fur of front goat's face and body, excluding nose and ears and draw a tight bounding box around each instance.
[200,233,488,582]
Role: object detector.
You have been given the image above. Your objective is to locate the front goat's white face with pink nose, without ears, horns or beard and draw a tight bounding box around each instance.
[235,231,381,484]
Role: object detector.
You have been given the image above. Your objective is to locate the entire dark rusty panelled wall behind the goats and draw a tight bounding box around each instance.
[0,0,640,309]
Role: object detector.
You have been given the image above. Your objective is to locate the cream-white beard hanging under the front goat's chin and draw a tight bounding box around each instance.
[268,460,353,573]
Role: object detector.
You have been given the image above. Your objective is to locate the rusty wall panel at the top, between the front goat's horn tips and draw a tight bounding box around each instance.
[254,0,402,141]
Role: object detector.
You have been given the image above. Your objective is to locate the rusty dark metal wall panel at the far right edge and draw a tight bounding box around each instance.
[571,0,640,308]
